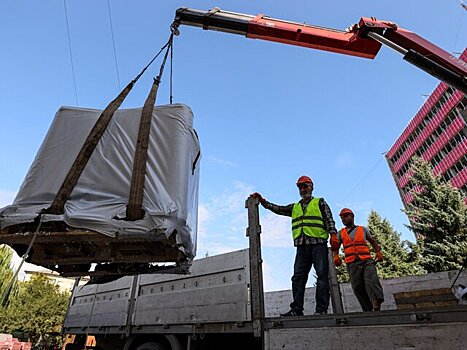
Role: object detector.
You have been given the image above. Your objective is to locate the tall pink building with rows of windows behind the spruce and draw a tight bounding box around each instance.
[386,49,467,205]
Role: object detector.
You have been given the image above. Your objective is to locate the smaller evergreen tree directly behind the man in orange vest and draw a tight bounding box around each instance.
[337,210,424,283]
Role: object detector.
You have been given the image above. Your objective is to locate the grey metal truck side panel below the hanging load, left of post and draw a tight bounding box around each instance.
[64,249,251,334]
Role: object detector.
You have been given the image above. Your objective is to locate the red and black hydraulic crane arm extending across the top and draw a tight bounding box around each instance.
[172,8,467,93]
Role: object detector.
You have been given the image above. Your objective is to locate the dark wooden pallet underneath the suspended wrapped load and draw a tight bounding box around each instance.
[0,222,187,276]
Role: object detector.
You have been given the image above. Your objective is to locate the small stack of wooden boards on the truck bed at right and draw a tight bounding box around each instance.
[394,288,457,310]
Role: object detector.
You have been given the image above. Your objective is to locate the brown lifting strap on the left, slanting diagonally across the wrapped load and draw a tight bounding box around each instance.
[42,34,173,215]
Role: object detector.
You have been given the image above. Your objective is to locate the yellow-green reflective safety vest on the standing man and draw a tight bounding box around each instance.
[292,198,329,239]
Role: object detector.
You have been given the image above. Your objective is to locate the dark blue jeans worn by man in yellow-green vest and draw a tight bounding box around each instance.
[290,244,329,312]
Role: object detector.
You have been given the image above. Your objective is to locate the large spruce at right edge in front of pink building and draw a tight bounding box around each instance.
[405,158,467,272]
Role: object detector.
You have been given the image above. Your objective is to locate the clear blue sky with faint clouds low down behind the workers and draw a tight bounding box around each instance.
[0,0,467,290]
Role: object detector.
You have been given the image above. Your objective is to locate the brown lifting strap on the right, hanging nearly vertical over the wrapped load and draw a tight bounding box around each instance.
[126,34,173,221]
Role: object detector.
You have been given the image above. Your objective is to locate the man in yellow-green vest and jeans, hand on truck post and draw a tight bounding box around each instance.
[251,176,337,317]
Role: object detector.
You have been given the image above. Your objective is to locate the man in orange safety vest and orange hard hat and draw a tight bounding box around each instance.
[330,208,384,311]
